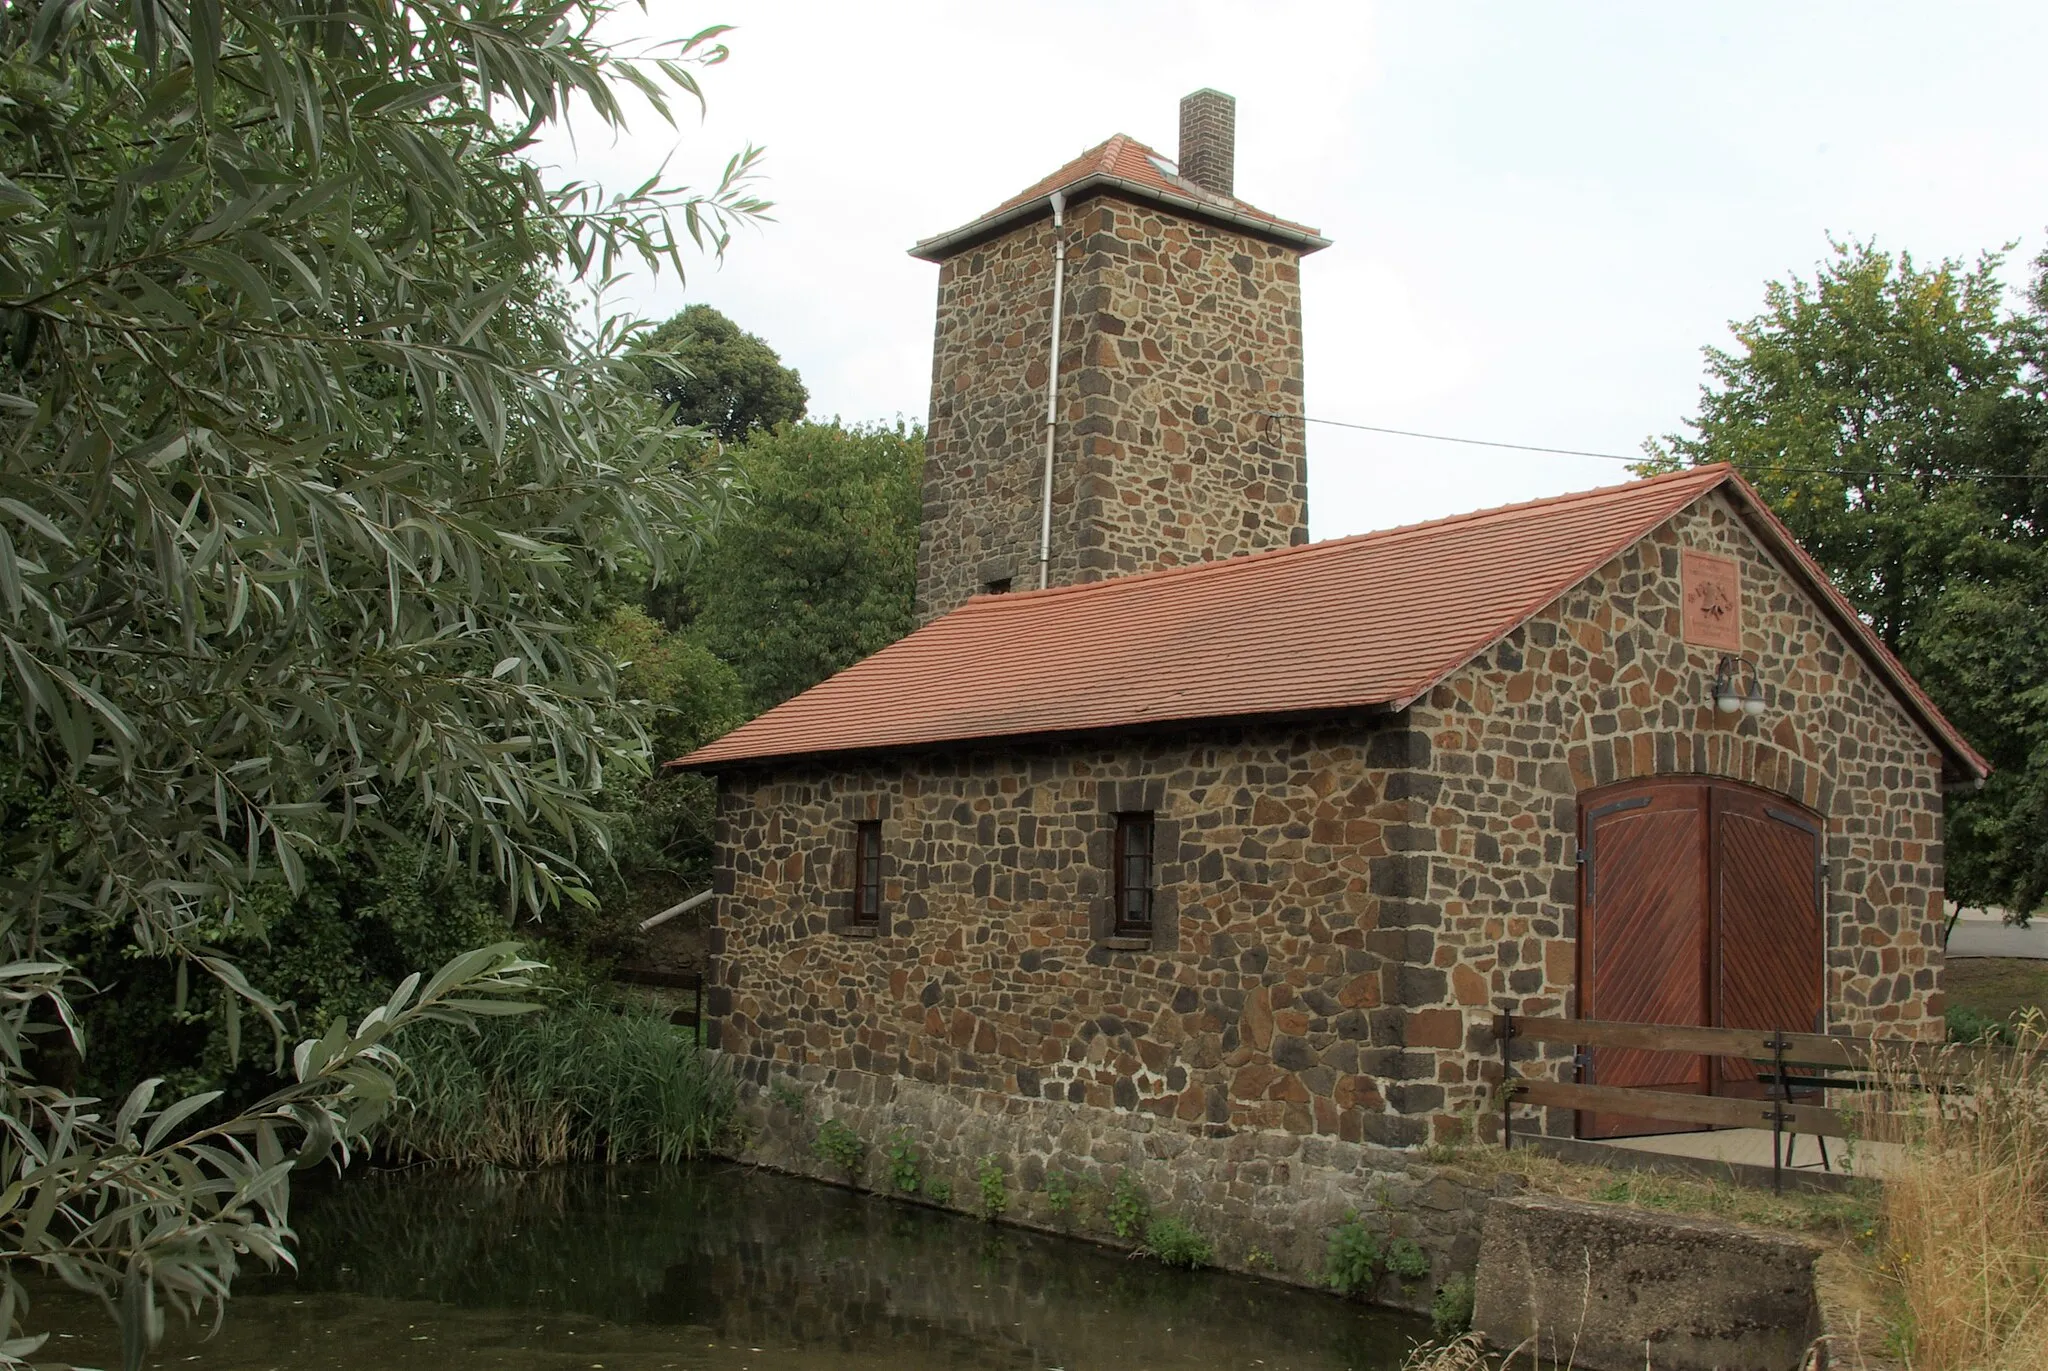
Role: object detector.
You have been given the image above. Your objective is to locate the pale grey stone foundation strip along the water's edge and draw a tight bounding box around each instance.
[737,1066,1518,1310]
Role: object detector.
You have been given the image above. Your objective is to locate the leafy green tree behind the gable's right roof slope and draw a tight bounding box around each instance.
[1651,244,2048,916]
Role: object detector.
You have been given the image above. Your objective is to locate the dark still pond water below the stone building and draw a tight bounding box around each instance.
[33,1164,1427,1371]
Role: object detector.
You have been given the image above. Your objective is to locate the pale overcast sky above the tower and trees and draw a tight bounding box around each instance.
[545,0,2048,537]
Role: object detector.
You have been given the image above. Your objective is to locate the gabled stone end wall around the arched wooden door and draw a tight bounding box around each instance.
[1409,485,1942,1133]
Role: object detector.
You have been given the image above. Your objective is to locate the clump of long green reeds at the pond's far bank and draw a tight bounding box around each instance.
[379,998,737,1168]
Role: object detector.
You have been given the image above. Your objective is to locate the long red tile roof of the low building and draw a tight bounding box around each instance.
[672,465,1989,779]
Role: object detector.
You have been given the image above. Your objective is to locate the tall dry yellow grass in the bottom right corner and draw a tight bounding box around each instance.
[1866,1012,2048,1371]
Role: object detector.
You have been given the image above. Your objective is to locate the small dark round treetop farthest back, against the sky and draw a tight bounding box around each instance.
[639,305,811,443]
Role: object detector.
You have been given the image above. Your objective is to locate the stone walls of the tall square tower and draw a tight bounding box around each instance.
[918,197,1309,619]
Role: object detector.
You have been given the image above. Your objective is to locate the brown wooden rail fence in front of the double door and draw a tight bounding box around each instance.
[1493,1014,1999,1187]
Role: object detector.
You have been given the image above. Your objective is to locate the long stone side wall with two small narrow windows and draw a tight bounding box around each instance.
[711,721,1442,1144]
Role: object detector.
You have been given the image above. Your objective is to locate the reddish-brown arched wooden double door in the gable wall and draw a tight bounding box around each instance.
[1579,777,1827,1137]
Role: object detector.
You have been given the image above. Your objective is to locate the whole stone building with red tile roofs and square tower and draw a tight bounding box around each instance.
[680,96,1985,1269]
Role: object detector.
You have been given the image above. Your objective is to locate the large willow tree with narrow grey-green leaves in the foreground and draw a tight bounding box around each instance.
[0,0,760,1367]
